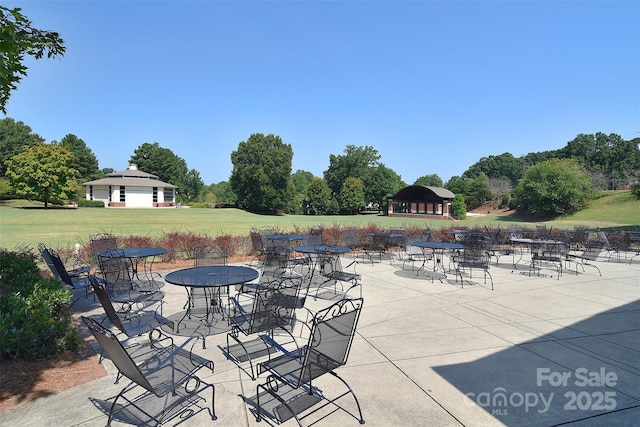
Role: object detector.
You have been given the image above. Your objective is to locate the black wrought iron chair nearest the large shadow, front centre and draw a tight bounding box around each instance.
[256,298,365,426]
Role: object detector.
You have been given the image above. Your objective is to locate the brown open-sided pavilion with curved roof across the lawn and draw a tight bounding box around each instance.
[387,185,456,219]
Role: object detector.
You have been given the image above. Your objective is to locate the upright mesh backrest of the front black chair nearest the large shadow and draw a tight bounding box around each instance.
[298,298,363,386]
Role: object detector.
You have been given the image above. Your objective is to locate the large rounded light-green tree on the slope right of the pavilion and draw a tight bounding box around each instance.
[514,159,594,217]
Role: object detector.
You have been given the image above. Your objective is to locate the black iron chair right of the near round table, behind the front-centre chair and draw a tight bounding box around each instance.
[223,281,300,380]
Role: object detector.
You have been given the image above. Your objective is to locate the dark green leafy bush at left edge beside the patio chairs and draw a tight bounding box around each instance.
[0,248,82,360]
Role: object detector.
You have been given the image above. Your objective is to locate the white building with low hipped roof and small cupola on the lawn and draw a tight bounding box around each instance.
[82,164,177,208]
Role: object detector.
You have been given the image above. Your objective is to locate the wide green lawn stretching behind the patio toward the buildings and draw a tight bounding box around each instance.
[0,191,640,249]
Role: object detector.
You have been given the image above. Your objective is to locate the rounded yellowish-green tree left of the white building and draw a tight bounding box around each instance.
[6,143,78,208]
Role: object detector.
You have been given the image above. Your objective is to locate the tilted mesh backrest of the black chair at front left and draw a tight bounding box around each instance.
[82,316,157,395]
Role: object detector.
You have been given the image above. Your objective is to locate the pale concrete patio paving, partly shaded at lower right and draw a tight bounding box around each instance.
[0,251,640,427]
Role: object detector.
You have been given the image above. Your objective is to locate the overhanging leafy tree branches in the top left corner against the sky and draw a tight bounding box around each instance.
[0,6,66,114]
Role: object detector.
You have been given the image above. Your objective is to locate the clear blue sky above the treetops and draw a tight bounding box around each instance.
[3,1,640,185]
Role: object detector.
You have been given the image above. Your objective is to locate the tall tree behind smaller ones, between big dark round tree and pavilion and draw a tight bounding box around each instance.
[324,145,380,194]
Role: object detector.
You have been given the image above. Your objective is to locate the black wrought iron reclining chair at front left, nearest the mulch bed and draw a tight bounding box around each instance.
[82,316,217,425]
